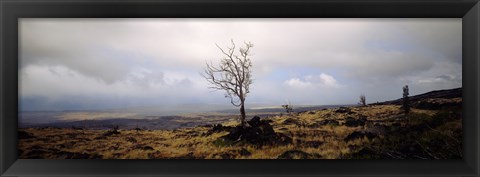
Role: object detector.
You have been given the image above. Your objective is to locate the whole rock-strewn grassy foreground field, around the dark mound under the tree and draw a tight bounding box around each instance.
[18,98,462,159]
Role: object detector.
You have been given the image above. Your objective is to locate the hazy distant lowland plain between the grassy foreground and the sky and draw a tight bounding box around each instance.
[19,105,344,130]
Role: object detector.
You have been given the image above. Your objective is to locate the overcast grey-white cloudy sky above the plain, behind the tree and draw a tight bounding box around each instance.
[19,18,462,110]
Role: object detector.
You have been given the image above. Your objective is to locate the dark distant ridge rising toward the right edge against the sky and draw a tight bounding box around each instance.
[372,87,462,105]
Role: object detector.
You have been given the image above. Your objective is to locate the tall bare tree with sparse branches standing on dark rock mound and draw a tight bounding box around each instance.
[202,40,253,127]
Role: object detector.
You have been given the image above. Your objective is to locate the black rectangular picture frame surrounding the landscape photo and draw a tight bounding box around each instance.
[0,0,480,176]
